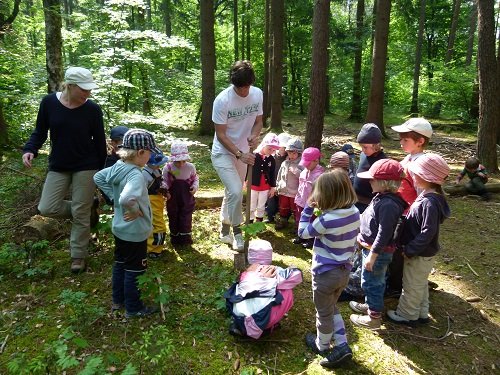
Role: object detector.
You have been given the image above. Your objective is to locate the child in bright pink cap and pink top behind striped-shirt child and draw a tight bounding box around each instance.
[293,147,325,248]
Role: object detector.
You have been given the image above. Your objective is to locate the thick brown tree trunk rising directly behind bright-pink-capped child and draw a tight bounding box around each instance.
[305,0,330,148]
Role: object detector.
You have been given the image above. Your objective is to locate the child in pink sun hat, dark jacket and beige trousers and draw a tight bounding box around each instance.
[387,153,450,326]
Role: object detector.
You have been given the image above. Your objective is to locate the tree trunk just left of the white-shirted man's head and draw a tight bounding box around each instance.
[200,0,216,135]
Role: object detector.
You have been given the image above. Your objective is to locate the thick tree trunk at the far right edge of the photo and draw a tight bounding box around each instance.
[477,0,499,172]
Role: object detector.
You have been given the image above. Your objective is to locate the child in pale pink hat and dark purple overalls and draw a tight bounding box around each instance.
[161,142,199,246]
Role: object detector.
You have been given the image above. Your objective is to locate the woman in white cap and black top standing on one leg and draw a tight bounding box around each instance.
[23,67,106,272]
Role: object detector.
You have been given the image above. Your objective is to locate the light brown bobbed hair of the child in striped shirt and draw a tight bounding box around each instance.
[311,169,357,210]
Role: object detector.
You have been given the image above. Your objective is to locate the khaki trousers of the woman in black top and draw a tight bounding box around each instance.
[38,170,97,258]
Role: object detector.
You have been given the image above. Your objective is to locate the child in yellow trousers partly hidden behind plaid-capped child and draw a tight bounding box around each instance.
[142,153,168,260]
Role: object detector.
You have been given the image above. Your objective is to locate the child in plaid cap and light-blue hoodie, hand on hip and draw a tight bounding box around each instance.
[94,129,161,318]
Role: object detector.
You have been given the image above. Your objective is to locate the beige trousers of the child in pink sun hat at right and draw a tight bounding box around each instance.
[396,256,435,320]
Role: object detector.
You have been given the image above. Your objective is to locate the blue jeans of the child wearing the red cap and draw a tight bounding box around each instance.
[361,248,392,318]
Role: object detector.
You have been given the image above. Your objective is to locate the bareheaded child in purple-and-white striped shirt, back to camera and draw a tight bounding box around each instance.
[298,169,360,368]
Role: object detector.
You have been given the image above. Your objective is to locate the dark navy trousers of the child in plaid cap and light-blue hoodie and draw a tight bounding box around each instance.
[112,236,147,313]
